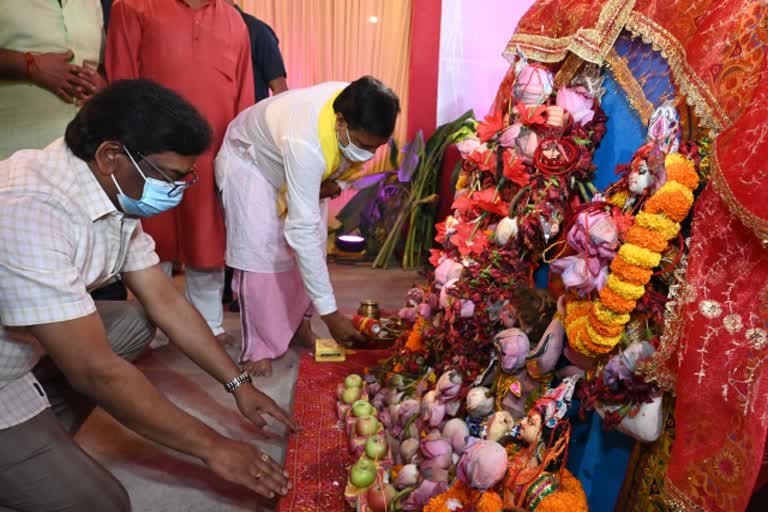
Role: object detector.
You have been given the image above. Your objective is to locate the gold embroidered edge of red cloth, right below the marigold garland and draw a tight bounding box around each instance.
[639,238,691,394]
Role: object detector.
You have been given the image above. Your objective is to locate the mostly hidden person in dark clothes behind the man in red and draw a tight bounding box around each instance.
[226,0,288,312]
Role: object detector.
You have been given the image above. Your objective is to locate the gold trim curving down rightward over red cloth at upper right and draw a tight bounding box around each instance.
[626,12,731,133]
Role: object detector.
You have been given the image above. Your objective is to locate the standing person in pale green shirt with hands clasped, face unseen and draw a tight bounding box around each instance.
[0,0,106,160]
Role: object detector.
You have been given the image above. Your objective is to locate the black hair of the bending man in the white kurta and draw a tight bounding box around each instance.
[333,76,400,137]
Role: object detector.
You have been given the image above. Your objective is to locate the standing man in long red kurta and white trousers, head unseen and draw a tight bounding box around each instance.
[105,0,254,341]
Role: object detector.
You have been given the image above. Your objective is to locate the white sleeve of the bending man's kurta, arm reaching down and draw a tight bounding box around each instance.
[282,138,337,315]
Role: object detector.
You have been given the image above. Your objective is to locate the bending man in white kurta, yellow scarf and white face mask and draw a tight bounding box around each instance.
[216,77,400,375]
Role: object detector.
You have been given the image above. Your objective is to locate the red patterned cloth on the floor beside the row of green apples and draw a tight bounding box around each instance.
[278,350,388,512]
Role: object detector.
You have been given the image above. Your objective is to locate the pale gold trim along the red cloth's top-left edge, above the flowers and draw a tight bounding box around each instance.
[503,0,635,64]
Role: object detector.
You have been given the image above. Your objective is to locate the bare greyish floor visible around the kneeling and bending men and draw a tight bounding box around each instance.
[77,265,419,512]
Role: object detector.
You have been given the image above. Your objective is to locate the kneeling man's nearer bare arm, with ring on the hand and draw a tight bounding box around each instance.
[29,313,288,497]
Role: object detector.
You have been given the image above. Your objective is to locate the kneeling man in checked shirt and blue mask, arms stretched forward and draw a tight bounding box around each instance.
[0,80,297,512]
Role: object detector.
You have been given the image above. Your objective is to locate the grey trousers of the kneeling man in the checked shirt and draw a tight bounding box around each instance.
[0,301,155,512]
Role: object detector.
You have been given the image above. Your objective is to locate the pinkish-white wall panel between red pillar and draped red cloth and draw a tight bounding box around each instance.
[437,0,534,125]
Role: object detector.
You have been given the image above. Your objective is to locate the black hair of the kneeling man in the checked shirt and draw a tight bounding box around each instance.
[64,80,212,161]
